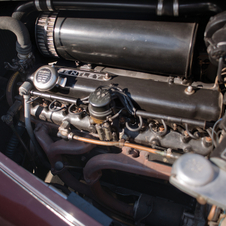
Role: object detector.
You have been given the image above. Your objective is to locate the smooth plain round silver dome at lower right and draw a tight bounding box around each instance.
[175,154,214,187]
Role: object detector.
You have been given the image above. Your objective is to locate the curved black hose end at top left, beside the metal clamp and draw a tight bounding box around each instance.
[12,2,36,20]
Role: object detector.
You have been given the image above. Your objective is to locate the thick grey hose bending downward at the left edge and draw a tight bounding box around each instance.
[0,16,32,55]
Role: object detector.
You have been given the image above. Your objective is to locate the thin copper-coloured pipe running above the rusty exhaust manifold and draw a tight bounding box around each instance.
[65,133,180,159]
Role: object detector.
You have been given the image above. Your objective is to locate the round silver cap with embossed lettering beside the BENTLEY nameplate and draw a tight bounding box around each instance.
[34,66,59,91]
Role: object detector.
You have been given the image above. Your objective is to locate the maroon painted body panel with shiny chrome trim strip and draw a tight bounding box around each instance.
[0,153,100,226]
